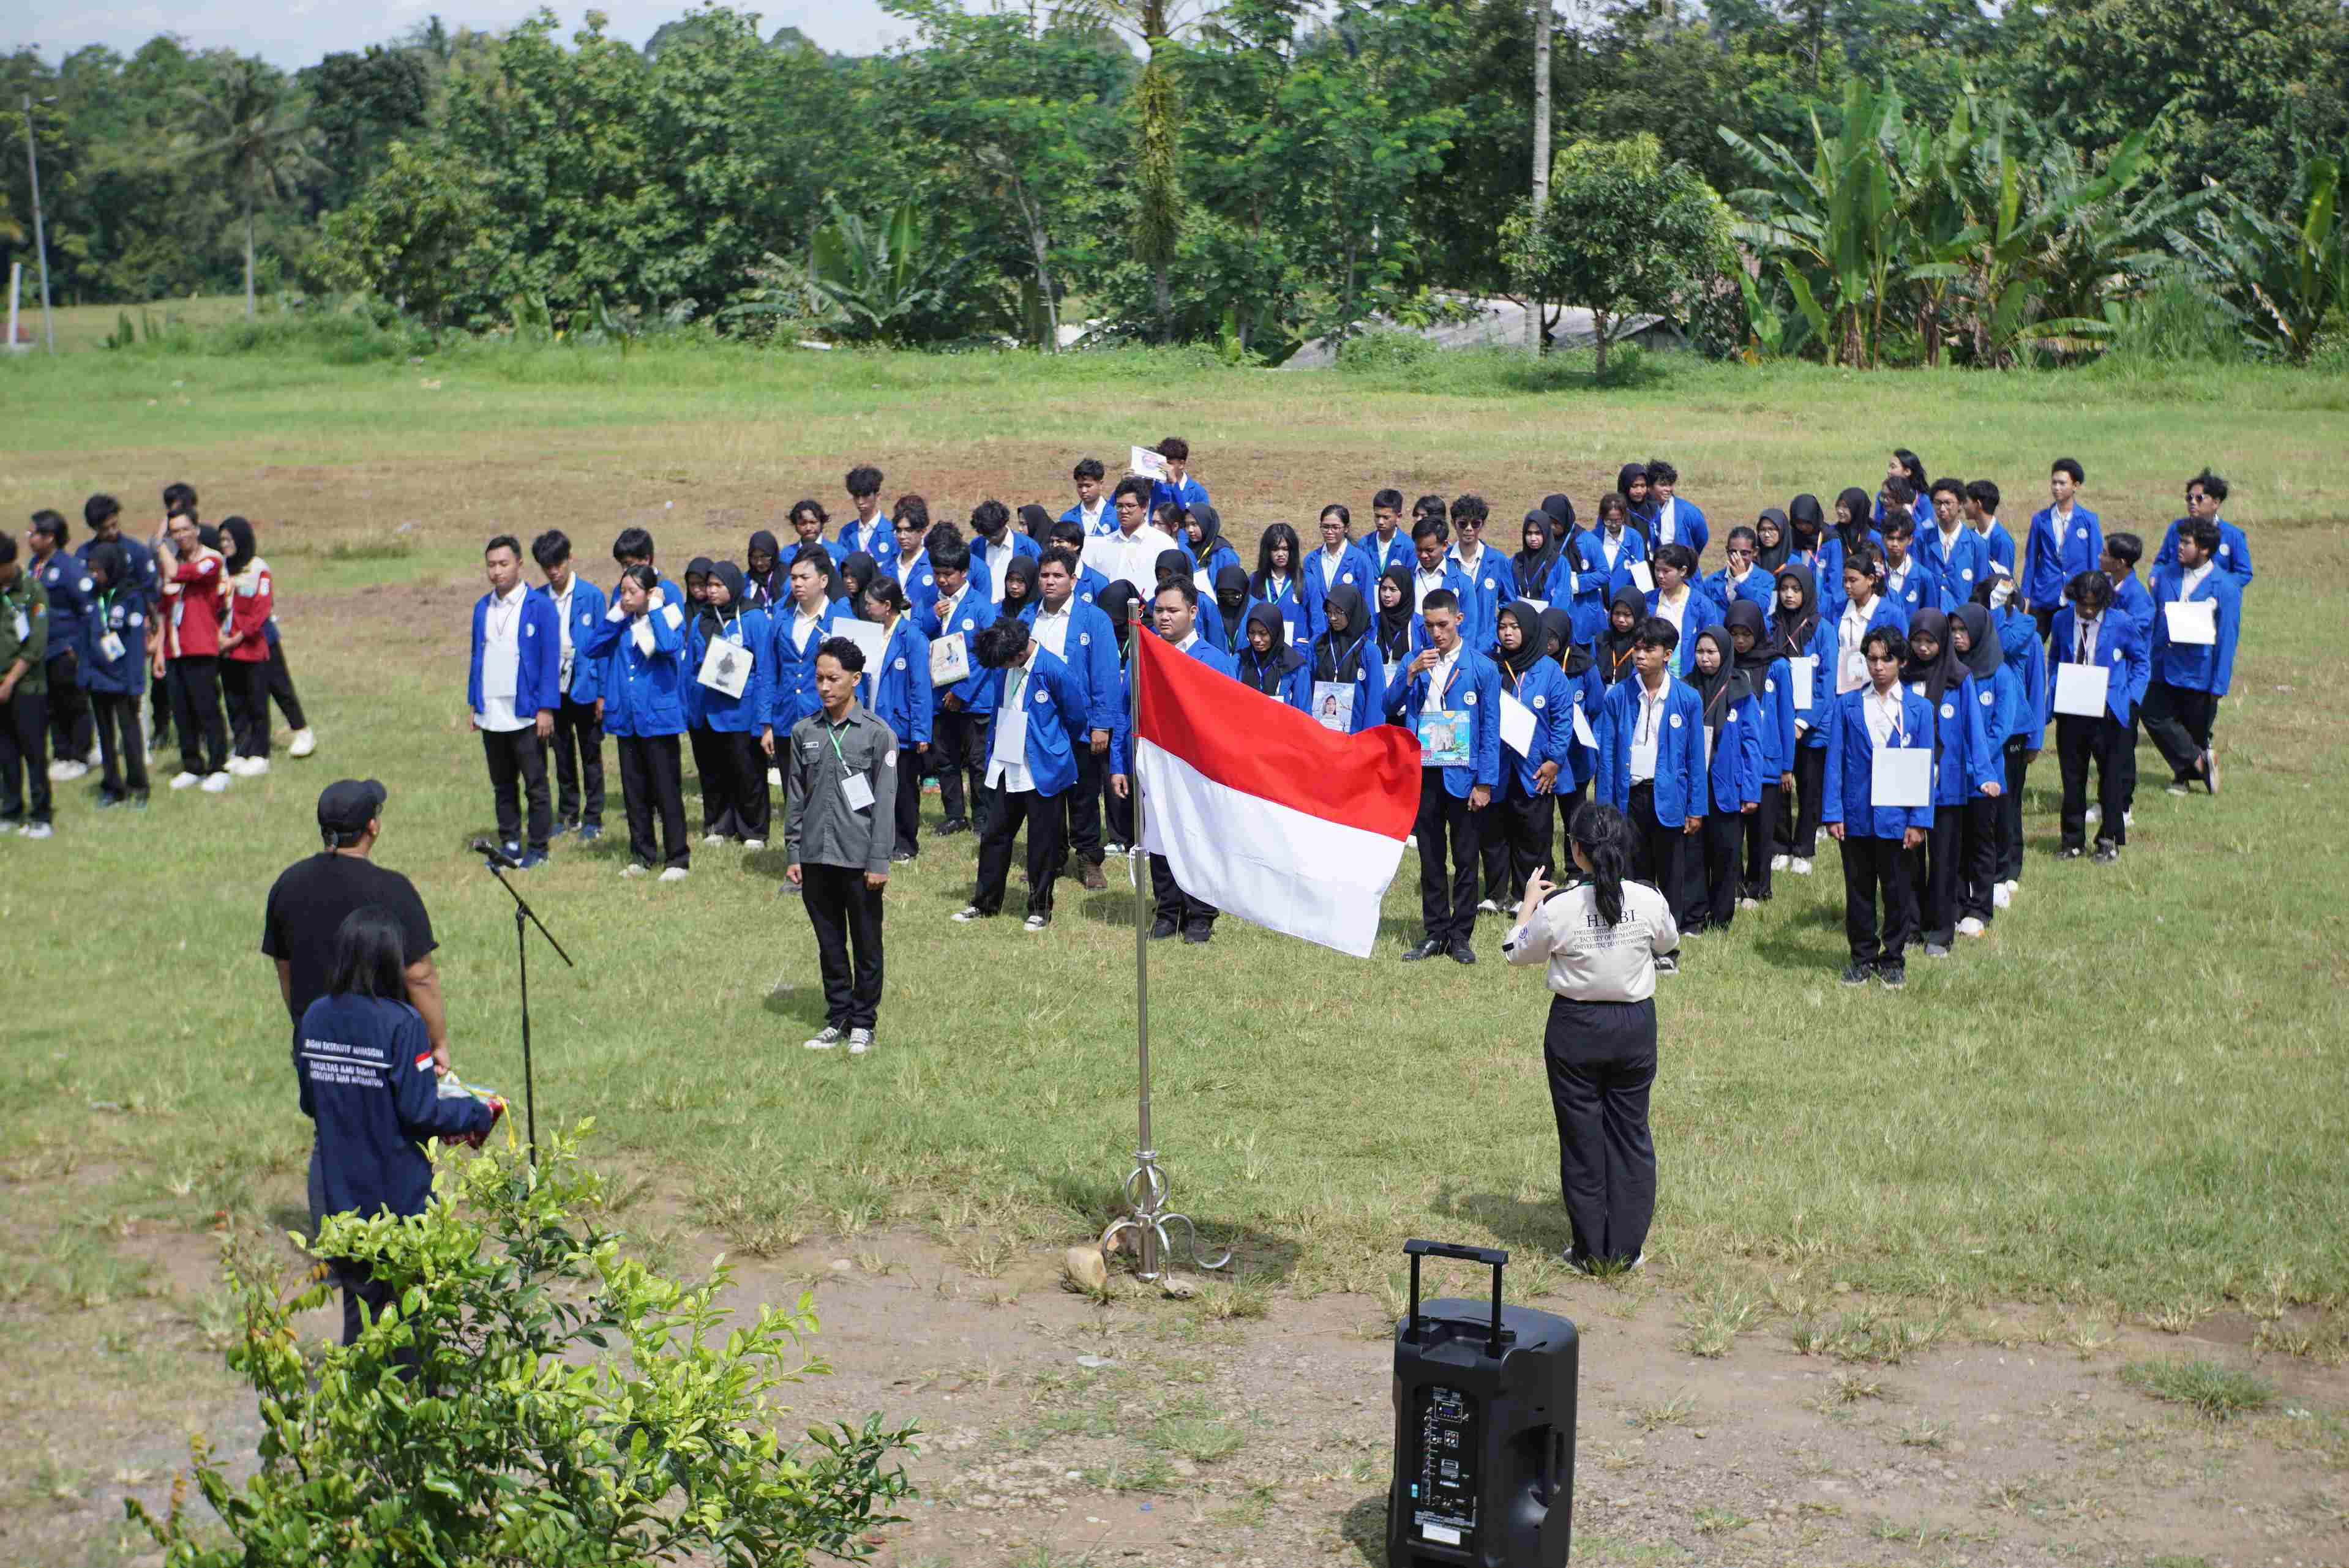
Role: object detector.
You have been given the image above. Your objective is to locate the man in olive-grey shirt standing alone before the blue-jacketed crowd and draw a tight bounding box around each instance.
[782,636,897,1056]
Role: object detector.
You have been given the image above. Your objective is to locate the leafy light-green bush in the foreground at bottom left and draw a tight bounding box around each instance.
[127,1124,914,1568]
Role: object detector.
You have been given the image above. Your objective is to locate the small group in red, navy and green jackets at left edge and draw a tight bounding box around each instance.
[0,483,317,838]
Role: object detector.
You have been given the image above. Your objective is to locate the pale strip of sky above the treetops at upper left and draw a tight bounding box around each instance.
[0,0,912,70]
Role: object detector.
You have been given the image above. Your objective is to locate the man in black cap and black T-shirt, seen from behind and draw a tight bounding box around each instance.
[261,779,449,1220]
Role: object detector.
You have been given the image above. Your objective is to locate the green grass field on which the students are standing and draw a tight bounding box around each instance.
[0,338,2349,1392]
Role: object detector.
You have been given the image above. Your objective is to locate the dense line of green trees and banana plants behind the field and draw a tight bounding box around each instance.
[0,0,2349,366]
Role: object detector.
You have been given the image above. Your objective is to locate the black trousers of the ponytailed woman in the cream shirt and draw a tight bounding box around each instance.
[1541,995,1656,1263]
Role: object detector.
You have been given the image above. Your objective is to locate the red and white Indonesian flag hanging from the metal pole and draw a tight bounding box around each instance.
[1134,634,1419,958]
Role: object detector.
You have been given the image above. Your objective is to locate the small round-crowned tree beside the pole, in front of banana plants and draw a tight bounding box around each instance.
[1501,134,1729,378]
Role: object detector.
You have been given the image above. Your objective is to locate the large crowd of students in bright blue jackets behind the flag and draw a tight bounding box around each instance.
[453,444,2250,979]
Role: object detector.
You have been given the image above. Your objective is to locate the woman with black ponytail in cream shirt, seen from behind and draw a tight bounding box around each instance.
[1501,801,1679,1270]
